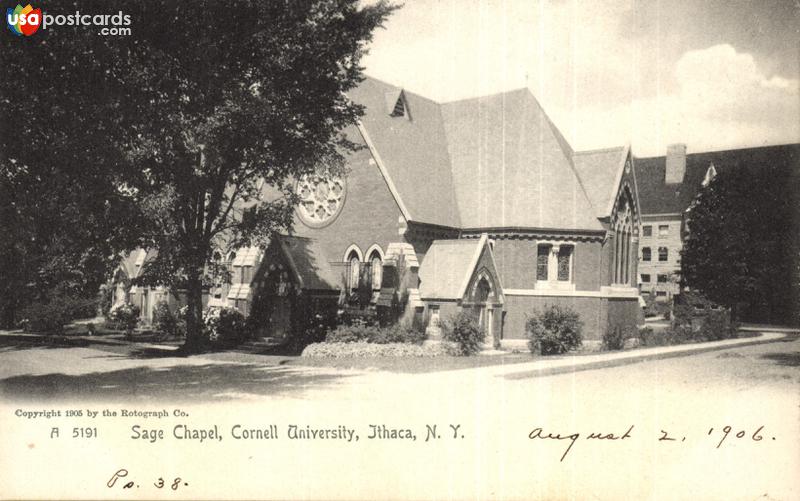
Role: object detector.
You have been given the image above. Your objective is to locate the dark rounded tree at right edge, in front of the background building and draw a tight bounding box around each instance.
[681,159,800,322]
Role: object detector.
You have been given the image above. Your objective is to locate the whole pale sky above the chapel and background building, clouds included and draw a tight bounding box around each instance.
[363,0,800,157]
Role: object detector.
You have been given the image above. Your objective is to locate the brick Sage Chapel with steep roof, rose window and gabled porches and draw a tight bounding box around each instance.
[120,78,641,345]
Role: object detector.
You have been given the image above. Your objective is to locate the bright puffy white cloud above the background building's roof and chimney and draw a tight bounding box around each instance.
[555,44,800,156]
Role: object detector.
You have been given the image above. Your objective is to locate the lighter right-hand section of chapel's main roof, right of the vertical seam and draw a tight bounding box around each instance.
[442,89,601,230]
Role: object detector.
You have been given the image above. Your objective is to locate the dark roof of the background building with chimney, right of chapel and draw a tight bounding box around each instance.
[634,144,800,215]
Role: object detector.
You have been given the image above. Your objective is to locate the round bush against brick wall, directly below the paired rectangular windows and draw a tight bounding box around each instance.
[525,305,583,355]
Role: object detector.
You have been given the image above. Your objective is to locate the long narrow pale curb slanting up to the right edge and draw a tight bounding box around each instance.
[504,332,797,379]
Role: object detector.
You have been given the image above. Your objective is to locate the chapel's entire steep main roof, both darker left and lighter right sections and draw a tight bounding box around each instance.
[350,78,602,230]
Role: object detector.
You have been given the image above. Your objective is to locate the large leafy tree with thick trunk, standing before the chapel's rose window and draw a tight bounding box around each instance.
[0,0,394,350]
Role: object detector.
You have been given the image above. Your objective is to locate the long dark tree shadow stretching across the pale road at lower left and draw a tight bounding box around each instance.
[0,364,354,402]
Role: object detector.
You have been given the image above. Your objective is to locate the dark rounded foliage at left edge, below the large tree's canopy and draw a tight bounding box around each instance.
[0,164,135,327]
